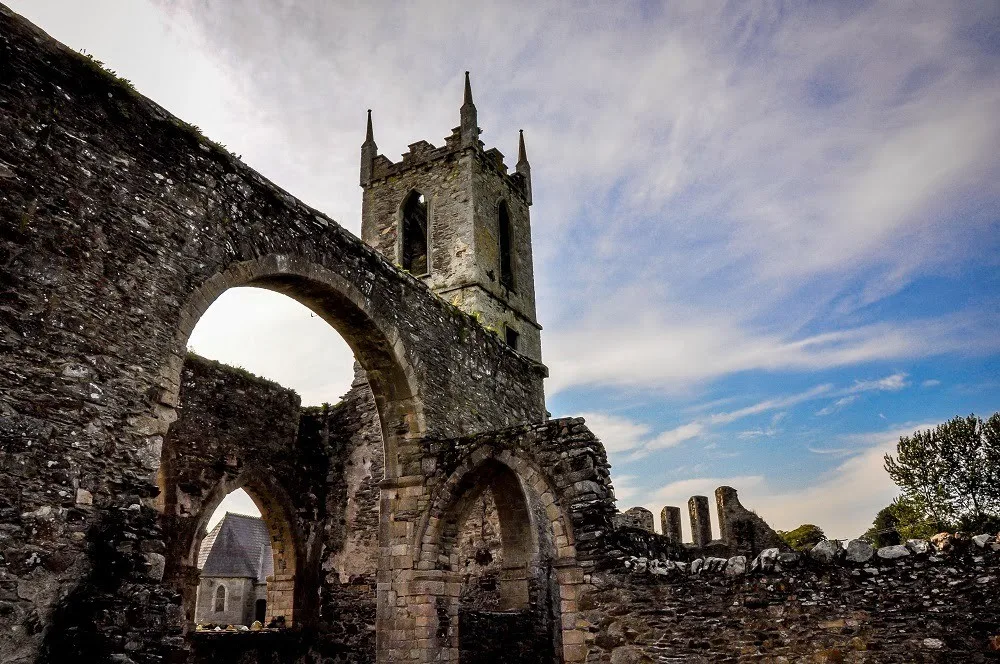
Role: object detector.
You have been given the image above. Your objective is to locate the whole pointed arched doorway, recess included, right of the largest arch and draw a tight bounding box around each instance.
[418,449,582,664]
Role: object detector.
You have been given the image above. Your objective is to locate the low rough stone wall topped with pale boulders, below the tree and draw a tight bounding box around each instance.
[580,536,1000,664]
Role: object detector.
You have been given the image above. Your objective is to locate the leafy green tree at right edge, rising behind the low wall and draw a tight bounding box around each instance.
[876,412,1000,532]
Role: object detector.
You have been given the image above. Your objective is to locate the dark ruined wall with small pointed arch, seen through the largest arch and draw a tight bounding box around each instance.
[169,355,383,662]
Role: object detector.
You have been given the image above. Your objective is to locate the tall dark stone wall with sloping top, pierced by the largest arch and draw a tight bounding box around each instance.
[0,7,545,662]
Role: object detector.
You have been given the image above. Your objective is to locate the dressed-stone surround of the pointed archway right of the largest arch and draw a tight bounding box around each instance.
[414,446,585,662]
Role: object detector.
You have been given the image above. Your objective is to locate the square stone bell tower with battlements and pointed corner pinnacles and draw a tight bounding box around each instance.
[361,72,542,362]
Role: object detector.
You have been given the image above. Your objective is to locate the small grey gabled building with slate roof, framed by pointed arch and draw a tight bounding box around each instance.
[194,512,274,625]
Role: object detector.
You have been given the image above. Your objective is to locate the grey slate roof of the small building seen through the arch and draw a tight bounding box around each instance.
[198,512,274,581]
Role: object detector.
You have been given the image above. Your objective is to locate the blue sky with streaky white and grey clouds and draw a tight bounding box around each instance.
[9,0,1000,537]
